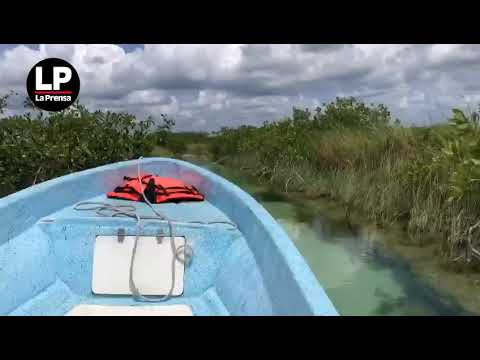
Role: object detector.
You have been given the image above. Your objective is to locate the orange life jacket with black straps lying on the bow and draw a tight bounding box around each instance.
[107,174,205,204]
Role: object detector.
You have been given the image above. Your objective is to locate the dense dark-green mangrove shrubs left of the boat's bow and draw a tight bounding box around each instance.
[0,104,162,196]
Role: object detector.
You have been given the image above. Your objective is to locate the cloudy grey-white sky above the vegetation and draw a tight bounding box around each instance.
[0,44,480,130]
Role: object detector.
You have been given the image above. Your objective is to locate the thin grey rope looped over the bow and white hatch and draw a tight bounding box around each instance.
[73,157,237,302]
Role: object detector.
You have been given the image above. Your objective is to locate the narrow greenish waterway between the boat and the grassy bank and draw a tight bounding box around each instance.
[186,158,480,315]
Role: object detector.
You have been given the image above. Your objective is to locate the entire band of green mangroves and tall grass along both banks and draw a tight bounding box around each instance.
[0,94,480,266]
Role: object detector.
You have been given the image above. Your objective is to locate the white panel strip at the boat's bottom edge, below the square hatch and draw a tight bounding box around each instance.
[66,305,193,316]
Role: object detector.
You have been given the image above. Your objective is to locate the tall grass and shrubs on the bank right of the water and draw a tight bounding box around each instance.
[212,98,480,263]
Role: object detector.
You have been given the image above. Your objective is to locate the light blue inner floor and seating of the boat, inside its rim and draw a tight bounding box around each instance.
[0,195,272,315]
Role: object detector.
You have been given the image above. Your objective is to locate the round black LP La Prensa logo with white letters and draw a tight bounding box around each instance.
[27,58,80,111]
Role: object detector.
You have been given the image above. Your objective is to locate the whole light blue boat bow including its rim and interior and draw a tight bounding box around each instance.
[0,158,337,315]
